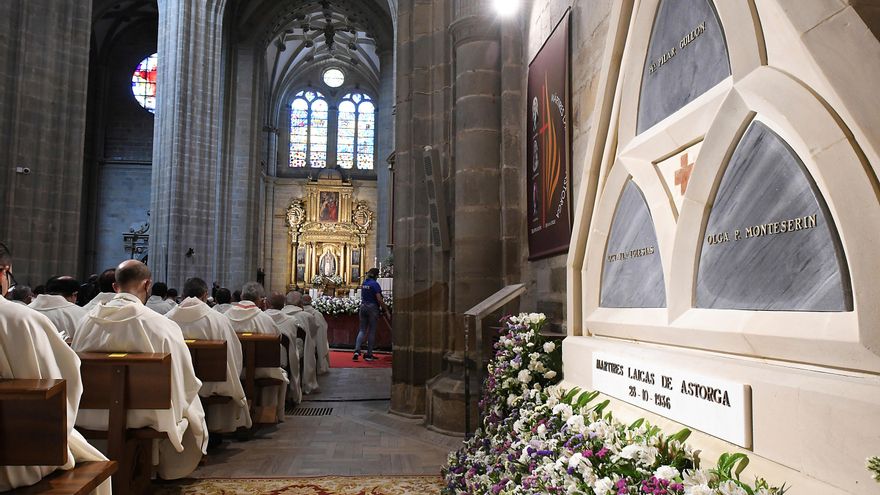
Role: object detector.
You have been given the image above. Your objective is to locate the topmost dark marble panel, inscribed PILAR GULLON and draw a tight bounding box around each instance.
[638,0,730,133]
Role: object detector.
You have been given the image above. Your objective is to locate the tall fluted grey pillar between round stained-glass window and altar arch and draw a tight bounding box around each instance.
[149,0,227,287]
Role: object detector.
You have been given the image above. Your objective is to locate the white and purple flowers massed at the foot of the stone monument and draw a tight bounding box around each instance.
[444,313,786,495]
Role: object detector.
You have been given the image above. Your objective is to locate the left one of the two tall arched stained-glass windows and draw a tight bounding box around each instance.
[290,91,329,168]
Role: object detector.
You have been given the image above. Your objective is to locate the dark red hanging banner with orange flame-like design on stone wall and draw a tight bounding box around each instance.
[526,12,571,260]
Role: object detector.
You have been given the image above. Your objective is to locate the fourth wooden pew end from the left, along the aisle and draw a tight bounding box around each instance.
[238,333,285,426]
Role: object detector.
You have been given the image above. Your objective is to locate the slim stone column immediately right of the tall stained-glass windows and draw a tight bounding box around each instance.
[374,50,394,261]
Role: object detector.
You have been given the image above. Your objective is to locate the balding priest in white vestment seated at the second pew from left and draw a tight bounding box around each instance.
[73,260,208,480]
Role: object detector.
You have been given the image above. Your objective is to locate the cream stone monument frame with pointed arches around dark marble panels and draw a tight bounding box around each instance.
[563,0,880,494]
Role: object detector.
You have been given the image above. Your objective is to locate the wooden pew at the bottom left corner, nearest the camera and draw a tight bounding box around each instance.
[0,379,117,495]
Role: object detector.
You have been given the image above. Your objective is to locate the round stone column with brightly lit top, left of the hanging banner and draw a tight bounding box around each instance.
[427,0,504,432]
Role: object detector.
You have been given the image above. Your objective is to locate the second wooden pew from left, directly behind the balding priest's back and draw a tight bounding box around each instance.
[78,352,171,494]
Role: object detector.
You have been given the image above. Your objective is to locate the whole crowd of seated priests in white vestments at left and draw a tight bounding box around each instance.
[0,243,329,493]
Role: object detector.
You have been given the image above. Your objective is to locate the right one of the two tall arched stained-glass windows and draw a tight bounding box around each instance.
[336,93,376,170]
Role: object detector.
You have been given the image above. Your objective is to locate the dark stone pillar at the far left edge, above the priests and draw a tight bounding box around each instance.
[0,0,91,285]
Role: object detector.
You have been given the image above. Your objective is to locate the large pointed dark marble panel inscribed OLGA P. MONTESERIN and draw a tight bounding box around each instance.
[696,121,852,311]
